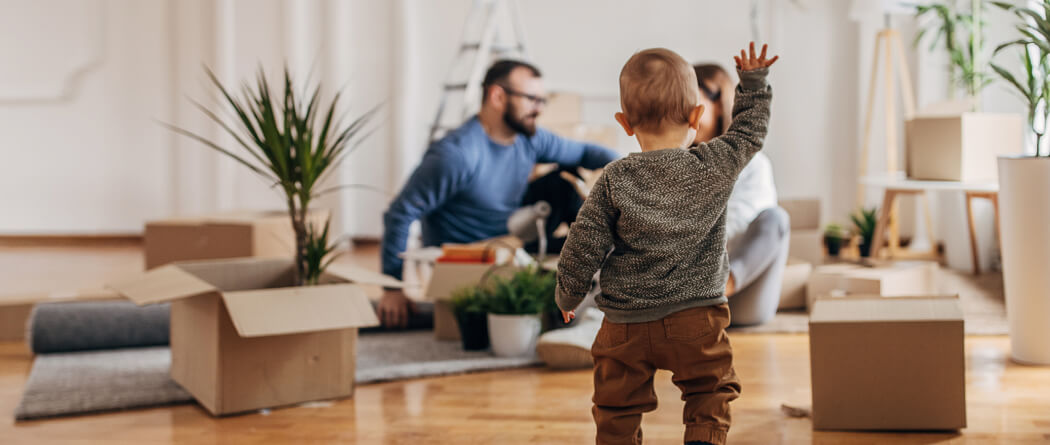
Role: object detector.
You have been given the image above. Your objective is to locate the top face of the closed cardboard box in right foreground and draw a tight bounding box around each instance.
[810,296,963,324]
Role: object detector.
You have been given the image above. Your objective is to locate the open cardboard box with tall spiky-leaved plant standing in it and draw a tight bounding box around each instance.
[122,69,392,415]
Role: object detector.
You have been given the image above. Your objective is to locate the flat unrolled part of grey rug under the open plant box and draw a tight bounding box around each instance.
[15,331,539,420]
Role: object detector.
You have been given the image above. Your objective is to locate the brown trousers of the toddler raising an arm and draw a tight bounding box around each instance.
[591,304,740,445]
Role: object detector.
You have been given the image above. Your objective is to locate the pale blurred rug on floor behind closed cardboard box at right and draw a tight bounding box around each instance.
[730,268,1008,335]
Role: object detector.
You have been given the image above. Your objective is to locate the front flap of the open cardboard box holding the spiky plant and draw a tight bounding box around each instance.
[223,284,379,337]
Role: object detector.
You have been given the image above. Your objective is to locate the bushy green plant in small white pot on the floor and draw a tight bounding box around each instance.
[483,264,555,357]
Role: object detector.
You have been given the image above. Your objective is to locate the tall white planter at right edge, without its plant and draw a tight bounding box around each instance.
[999,156,1050,365]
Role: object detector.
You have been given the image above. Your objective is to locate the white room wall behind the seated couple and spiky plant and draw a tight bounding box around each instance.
[0,0,1033,249]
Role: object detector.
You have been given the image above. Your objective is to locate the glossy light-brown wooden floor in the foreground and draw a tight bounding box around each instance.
[0,238,1050,445]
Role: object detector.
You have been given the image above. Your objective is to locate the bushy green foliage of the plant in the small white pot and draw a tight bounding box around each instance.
[483,266,557,315]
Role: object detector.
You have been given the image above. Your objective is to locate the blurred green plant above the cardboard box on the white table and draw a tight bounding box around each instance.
[915,0,991,101]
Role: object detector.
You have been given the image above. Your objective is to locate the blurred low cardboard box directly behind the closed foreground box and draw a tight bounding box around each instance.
[805,261,940,309]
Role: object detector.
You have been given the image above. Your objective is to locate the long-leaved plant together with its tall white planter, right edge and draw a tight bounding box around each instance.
[992,0,1050,365]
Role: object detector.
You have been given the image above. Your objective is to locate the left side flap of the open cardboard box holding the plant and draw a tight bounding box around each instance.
[106,266,217,305]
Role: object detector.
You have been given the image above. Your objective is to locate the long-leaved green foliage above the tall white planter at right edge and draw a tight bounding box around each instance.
[991,0,1050,156]
